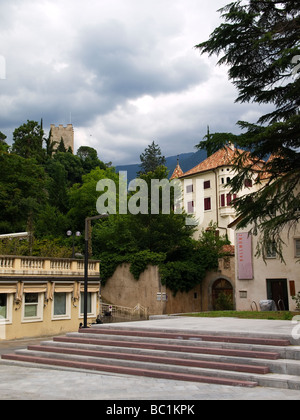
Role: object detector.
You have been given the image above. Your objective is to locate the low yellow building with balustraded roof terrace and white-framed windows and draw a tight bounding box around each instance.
[0,256,100,340]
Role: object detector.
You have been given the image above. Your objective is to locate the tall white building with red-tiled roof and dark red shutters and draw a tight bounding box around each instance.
[171,144,264,244]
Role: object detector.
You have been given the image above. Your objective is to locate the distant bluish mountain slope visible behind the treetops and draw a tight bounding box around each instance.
[116,150,207,182]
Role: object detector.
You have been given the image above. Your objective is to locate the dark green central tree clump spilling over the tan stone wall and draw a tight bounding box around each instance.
[93,166,227,294]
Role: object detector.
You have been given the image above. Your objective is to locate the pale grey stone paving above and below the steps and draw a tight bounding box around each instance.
[0,317,300,402]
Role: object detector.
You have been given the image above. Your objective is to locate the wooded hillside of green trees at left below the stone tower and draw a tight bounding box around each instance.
[0,120,106,255]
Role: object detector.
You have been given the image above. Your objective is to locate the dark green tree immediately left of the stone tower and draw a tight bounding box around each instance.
[12,120,45,163]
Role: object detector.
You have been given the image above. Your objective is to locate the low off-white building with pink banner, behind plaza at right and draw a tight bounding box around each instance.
[230,221,300,311]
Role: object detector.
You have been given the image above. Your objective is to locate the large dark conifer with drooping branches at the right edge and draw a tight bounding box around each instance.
[196,0,300,255]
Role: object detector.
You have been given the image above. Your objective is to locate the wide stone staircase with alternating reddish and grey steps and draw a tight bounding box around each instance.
[2,325,300,390]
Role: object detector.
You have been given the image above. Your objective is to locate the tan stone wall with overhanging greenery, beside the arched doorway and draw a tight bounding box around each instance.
[101,256,235,315]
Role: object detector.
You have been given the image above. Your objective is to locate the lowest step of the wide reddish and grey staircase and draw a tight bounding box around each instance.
[7,350,300,390]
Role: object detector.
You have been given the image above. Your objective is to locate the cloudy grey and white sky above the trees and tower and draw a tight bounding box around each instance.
[0,0,268,165]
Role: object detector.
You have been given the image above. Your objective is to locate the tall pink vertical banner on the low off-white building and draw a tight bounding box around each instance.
[236,232,253,280]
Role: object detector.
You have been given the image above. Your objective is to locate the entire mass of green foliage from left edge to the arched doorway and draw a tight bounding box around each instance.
[0,122,231,294]
